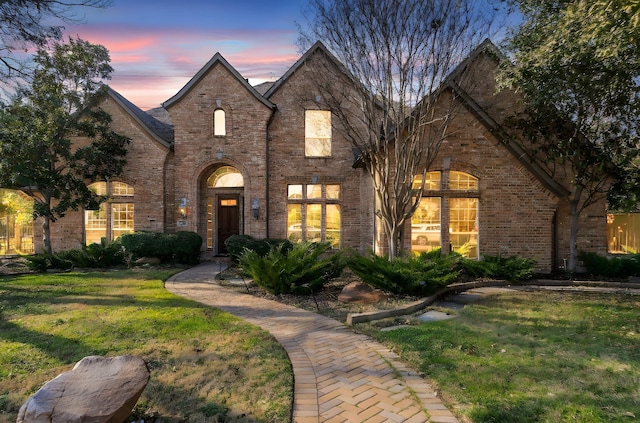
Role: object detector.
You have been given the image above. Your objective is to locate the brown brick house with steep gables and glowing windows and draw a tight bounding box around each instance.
[26,42,607,272]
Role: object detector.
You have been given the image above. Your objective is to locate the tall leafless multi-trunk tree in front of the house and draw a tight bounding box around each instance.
[300,0,504,258]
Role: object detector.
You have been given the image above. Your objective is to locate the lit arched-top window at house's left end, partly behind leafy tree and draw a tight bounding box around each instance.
[84,182,134,245]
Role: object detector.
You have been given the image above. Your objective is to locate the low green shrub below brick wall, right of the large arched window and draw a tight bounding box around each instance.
[462,256,536,282]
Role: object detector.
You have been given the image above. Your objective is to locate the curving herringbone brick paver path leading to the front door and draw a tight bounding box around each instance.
[165,263,458,423]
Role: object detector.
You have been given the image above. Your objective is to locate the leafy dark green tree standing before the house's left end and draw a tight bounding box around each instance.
[0,39,129,253]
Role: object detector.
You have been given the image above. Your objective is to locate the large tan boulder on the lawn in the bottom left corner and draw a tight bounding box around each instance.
[17,356,149,423]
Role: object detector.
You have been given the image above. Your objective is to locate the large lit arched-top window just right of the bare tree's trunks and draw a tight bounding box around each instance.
[411,170,479,258]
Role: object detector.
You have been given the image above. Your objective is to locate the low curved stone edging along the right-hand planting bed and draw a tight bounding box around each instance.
[347,279,640,326]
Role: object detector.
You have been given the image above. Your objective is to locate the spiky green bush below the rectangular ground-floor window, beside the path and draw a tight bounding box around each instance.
[239,242,345,295]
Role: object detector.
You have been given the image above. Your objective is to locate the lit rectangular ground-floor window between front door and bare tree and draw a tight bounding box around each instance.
[287,184,341,248]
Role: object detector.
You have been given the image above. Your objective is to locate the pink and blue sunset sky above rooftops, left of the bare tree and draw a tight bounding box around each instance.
[65,0,306,110]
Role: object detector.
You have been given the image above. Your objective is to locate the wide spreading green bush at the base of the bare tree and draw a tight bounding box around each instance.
[348,250,462,296]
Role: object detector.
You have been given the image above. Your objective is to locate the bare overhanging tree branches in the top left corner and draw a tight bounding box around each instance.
[0,0,111,83]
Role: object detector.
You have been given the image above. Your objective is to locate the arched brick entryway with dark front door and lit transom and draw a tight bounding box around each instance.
[200,164,244,254]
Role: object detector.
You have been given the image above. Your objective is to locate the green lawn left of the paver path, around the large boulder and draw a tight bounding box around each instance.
[0,270,293,422]
